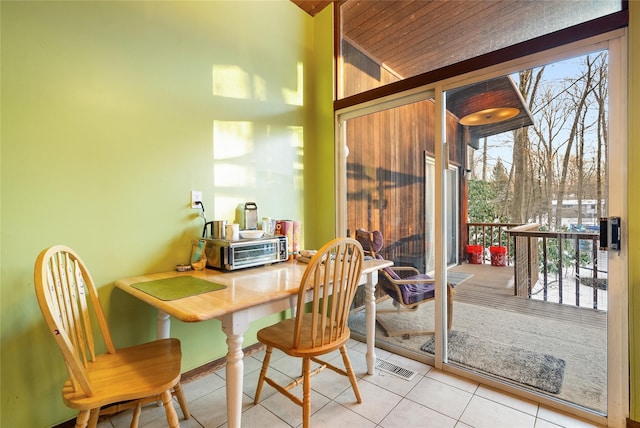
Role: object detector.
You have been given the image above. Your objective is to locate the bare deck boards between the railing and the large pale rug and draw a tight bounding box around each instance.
[450,263,607,329]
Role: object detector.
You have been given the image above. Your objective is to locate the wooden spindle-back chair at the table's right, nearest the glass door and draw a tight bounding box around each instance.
[254,238,364,428]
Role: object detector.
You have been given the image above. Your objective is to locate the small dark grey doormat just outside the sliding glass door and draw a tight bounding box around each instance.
[420,330,565,394]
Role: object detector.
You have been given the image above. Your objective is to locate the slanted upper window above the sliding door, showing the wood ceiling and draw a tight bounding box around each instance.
[339,0,621,98]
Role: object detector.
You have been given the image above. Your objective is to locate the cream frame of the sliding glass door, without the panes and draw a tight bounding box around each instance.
[335,29,629,426]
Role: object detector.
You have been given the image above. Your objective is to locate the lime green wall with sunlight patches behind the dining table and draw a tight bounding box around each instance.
[0,1,333,427]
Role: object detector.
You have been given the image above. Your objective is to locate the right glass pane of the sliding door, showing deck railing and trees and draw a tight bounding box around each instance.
[446,50,609,414]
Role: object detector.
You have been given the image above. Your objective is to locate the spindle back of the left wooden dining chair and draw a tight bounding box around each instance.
[34,245,115,396]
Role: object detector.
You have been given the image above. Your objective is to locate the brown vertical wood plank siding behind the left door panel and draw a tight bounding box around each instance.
[346,42,466,270]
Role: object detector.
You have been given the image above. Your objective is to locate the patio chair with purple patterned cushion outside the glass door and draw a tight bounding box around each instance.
[356,229,454,337]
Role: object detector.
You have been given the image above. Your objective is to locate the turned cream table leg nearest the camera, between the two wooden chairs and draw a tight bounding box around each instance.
[221,311,249,428]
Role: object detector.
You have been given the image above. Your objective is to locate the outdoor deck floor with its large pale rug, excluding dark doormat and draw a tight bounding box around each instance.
[349,263,607,412]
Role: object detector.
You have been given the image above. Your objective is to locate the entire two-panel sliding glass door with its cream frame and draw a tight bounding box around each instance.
[336,30,626,419]
